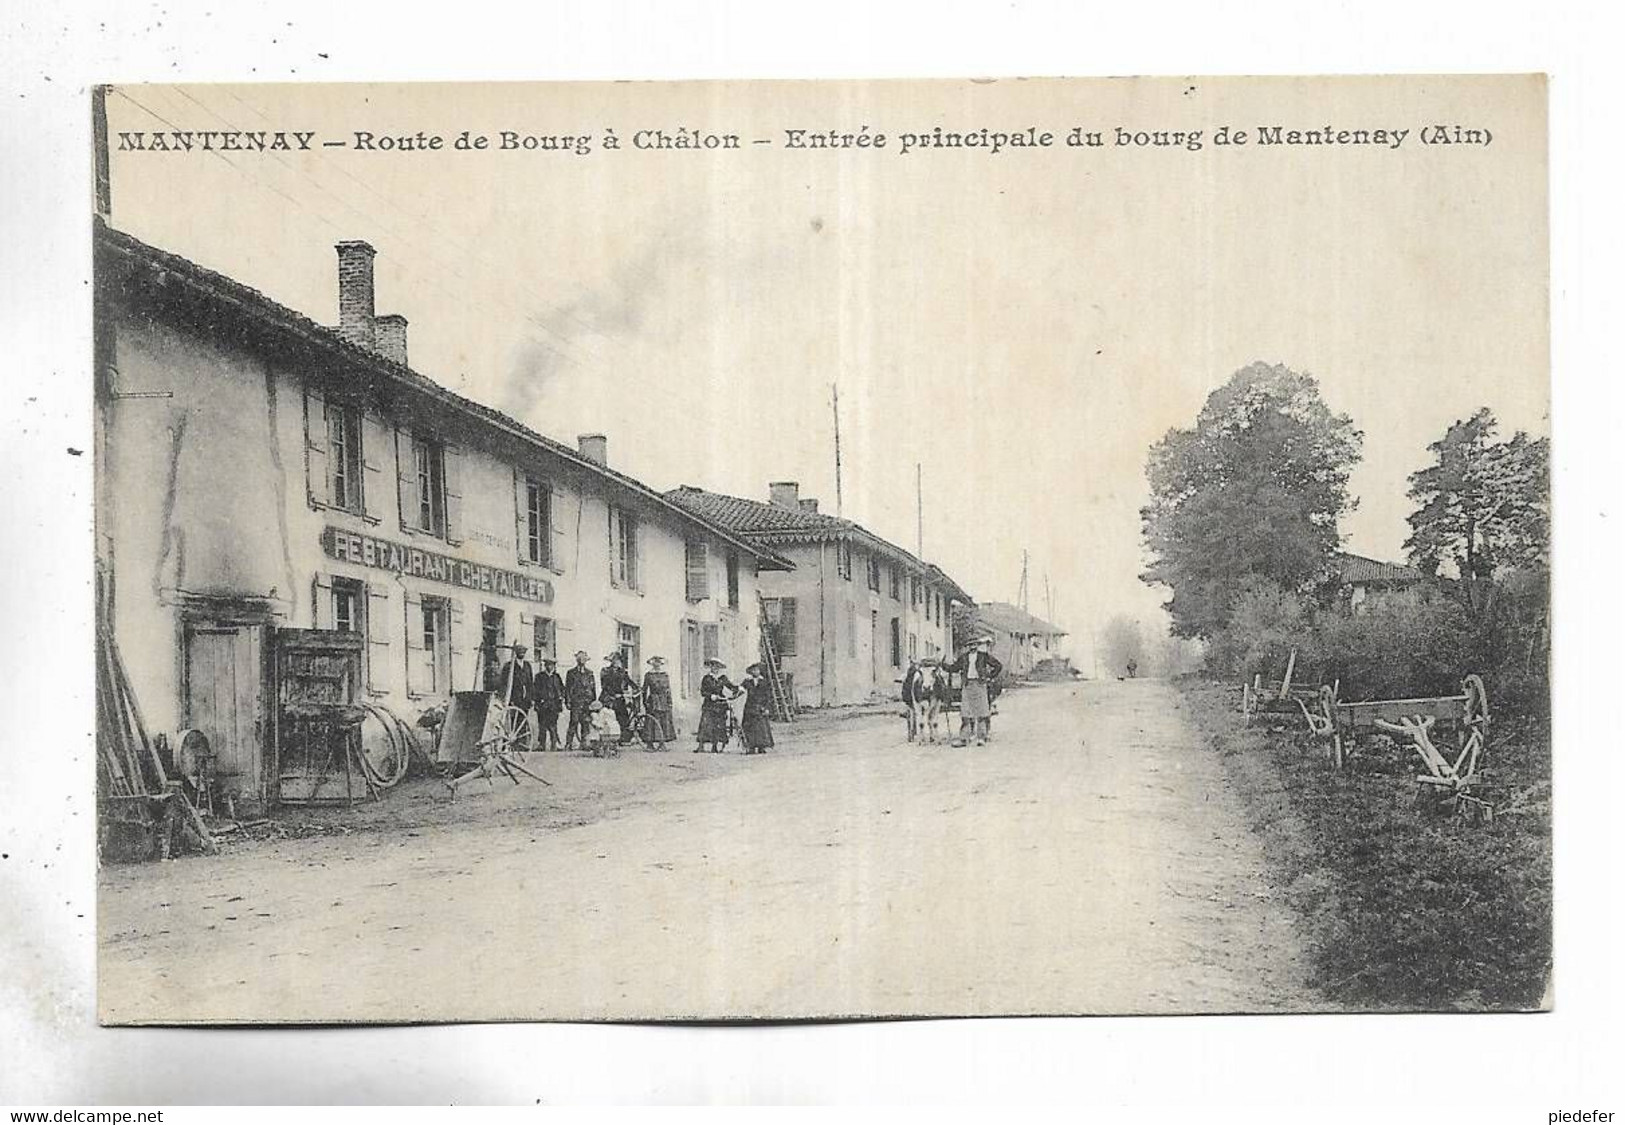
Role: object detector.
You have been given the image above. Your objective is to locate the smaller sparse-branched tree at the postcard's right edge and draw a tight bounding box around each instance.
[1406,406,1550,579]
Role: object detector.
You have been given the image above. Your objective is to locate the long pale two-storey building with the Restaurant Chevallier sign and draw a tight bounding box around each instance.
[96,226,788,816]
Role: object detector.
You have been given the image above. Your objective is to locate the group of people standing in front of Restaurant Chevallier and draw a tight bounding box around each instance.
[494,645,774,756]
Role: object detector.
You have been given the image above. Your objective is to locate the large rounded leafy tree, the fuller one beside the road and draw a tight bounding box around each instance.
[1141,363,1363,637]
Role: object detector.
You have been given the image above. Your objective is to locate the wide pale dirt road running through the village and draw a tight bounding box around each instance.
[99,681,1315,1023]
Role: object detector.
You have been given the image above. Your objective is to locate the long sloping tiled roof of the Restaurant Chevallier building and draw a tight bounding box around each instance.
[96,218,795,571]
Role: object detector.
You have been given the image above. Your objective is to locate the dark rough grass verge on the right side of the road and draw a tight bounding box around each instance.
[1181,681,1552,1011]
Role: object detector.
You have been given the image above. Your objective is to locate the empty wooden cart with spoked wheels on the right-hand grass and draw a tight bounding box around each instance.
[1303,676,1493,821]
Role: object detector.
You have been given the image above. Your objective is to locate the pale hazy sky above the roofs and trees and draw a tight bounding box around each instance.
[107,76,1549,660]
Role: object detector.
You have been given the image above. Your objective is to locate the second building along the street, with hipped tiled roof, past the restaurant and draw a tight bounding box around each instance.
[666,481,970,707]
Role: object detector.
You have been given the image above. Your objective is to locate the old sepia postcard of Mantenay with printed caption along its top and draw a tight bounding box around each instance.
[91,75,1552,1024]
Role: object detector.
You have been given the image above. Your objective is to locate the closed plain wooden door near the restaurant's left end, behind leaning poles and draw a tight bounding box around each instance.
[187,624,265,801]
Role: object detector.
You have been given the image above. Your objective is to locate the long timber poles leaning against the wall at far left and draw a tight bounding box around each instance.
[96,577,218,860]
